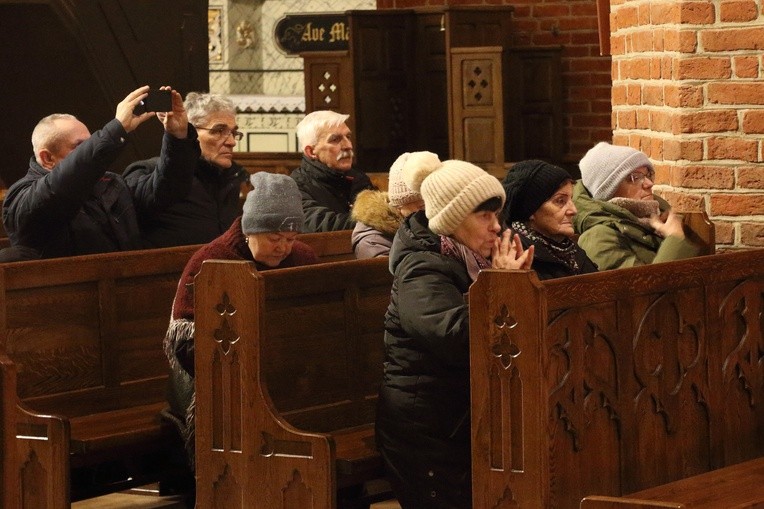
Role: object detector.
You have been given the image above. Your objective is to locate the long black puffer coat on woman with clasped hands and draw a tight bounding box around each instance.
[376,211,472,508]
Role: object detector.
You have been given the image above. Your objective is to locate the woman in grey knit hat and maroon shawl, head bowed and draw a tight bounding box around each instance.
[164,172,318,476]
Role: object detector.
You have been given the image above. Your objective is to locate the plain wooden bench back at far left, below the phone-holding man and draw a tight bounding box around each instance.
[0,246,198,417]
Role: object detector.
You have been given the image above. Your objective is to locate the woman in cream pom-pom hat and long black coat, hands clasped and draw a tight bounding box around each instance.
[376,155,533,509]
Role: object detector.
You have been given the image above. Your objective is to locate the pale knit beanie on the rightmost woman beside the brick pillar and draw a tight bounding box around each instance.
[578,141,655,201]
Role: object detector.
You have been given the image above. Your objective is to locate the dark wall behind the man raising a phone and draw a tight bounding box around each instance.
[0,0,209,187]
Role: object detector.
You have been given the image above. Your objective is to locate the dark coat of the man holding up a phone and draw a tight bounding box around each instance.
[3,119,199,258]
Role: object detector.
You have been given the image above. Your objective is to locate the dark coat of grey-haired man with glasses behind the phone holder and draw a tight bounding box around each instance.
[123,157,248,247]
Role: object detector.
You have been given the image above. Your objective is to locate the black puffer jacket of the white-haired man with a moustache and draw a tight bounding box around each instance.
[292,156,375,233]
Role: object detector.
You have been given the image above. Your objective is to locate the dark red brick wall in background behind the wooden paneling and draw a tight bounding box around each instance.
[377,0,612,163]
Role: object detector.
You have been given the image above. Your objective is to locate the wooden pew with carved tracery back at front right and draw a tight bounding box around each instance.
[469,250,764,509]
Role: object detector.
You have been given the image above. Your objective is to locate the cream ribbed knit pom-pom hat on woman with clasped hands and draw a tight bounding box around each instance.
[402,156,506,235]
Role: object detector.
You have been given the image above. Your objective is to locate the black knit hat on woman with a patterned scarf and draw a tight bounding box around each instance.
[502,159,573,223]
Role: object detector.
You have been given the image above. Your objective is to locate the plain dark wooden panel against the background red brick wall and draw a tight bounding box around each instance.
[504,47,563,162]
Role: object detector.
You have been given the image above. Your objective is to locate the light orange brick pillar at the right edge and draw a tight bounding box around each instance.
[610,0,764,249]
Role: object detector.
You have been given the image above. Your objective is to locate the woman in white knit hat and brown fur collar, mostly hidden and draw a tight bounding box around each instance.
[350,152,432,259]
